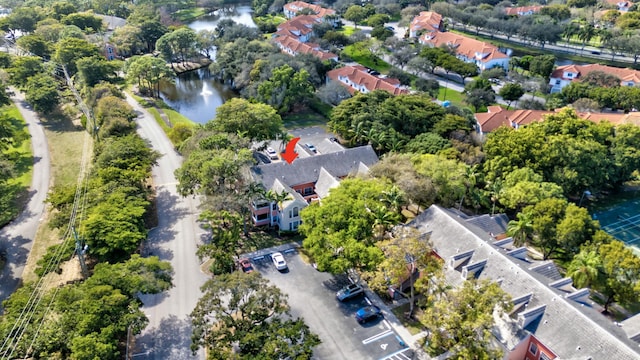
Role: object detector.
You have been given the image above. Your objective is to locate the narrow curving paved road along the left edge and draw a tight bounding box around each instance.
[0,90,51,309]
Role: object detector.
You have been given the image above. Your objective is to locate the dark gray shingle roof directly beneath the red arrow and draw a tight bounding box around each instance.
[251,145,378,189]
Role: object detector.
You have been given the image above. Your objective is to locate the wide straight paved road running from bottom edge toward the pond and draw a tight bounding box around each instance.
[127,95,206,360]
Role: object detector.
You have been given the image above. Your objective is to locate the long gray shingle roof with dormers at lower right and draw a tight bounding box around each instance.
[410,205,640,360]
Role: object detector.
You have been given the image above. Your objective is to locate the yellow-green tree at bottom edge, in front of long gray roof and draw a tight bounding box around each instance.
[420,279,512,359]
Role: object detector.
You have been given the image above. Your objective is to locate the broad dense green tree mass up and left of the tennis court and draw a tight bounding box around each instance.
[484,109,624,197]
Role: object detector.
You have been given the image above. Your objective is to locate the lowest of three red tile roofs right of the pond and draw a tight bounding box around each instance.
[327,65,409,95]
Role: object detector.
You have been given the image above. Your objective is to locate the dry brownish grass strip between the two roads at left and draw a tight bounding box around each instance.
[23,114,88,281]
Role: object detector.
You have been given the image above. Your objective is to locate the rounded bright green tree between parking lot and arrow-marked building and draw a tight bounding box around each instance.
[300,178,400,274]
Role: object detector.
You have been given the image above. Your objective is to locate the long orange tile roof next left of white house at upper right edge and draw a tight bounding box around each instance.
[420,32,509,62]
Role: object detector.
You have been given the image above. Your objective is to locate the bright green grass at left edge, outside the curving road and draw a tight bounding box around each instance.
[0,105,33,224]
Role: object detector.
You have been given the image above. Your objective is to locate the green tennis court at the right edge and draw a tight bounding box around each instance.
[593,199,640,255]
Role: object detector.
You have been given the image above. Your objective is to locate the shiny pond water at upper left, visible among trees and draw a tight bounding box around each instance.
[160,5,256,124]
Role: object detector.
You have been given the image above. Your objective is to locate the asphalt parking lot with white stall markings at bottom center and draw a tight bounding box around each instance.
[249,246,413,360]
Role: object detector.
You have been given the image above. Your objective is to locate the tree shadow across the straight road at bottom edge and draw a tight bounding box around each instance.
[131,315,200,360]
